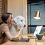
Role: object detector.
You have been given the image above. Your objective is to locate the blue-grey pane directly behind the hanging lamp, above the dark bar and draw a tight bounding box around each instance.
[31,3,45,25]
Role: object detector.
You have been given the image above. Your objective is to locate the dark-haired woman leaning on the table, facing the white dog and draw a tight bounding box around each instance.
[0,13,16,43]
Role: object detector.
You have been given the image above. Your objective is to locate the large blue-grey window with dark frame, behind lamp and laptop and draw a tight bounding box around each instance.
[27,1,45,33]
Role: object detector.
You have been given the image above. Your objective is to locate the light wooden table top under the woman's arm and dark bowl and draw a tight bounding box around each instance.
[2,34,45,45]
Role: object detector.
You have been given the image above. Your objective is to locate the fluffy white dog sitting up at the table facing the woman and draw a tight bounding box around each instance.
[10,16,26,36]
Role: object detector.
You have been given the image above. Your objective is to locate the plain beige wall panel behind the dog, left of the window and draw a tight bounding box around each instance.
[8,0,27,33]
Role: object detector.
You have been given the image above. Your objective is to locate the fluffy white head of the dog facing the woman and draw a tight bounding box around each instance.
[14,16,26,27]
